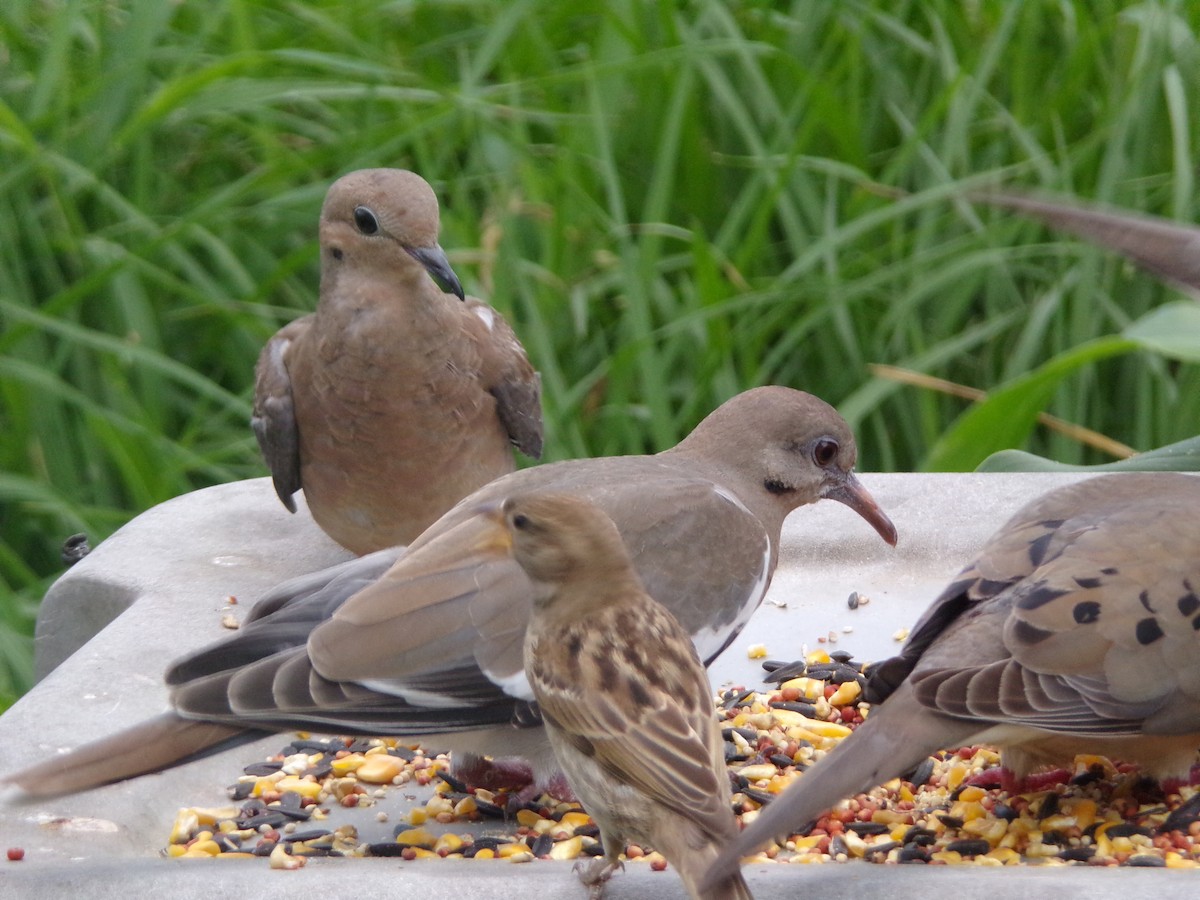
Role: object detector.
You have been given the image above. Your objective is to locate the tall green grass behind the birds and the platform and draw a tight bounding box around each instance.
[0,0,1200,704]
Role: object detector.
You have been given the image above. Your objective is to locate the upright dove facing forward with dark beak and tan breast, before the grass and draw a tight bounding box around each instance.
[251,169,542,553]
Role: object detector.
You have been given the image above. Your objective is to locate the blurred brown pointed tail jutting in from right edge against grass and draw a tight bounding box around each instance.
[971,191,1200,294]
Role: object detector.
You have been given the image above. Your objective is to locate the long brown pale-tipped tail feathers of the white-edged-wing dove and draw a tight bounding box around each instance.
[0,713,262,797]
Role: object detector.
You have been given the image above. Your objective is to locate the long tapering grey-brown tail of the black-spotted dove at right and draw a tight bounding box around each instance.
[701,684,979,888]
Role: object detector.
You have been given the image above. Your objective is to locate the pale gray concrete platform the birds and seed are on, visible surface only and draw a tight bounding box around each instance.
[0,474,1200,900]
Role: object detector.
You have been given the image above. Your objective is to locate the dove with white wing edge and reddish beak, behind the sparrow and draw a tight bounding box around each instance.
[7,386,896,793]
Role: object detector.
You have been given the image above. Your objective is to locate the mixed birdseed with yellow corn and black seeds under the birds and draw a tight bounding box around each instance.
[166,650,1200,869]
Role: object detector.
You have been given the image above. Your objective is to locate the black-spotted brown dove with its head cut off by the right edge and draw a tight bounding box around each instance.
[712,473,1200,877]
